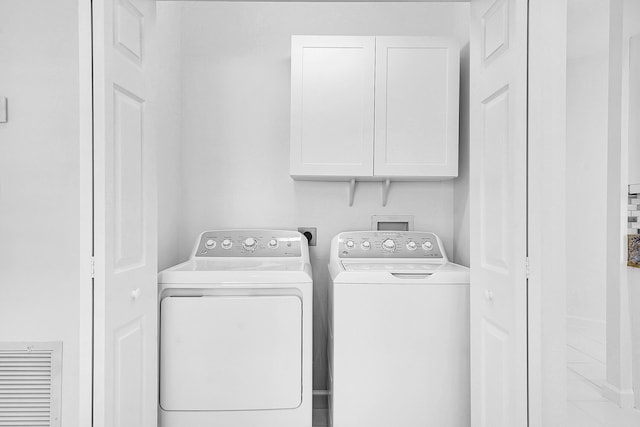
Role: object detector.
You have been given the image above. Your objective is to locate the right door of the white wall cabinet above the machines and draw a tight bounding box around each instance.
[374,37,460,179]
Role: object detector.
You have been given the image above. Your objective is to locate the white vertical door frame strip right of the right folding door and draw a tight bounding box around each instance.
[527,0,567,427]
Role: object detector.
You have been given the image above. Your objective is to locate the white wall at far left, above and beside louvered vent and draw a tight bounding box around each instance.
[0,0,81,427]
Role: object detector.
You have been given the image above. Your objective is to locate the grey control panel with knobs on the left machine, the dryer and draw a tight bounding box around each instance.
[195,230,307,258]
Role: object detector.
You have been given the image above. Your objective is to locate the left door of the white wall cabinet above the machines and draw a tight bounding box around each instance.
[290,36,375,179]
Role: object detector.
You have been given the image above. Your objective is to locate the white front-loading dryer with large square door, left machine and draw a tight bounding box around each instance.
[159,230,313,427]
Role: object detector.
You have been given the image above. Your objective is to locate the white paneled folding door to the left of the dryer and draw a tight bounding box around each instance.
[93,0,158,427]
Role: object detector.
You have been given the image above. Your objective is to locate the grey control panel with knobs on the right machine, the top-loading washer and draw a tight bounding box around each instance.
[338,231,444,259]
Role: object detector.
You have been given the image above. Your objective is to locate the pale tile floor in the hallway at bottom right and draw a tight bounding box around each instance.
[567,321,640,427]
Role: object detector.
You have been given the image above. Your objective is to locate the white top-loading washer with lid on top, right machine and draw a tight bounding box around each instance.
[328,231,470,427]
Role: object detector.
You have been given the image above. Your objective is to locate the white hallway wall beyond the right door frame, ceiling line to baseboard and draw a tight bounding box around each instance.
[566,52,609,324]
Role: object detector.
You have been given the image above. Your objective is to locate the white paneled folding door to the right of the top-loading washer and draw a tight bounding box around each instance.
[470,0,528,427]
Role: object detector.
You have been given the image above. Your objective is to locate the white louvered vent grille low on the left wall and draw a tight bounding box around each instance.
[0,342,62,427]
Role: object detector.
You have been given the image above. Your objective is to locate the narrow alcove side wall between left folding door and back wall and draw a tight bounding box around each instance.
[151,2,182,270]
